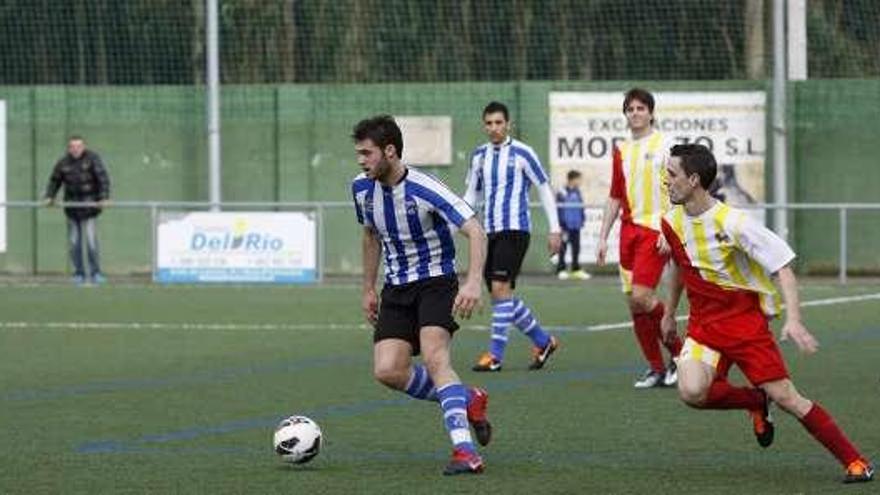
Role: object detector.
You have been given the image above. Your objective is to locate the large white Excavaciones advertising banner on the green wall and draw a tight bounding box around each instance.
[549,91,766,263]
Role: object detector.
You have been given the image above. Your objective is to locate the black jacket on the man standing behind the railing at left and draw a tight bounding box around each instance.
[46,150,110,219]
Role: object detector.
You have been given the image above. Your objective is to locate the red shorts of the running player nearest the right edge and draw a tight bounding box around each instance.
[680,311,788,386]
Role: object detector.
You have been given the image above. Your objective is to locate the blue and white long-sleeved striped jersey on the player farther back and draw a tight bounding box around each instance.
[464,137,555,233]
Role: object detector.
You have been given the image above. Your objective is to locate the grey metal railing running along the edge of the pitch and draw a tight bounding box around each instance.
[0,201,880,284]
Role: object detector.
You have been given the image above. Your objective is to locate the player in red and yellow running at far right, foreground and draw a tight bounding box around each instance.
[662,144,874,483]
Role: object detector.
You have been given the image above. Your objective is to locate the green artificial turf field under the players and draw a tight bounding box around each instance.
[0,278,880,494]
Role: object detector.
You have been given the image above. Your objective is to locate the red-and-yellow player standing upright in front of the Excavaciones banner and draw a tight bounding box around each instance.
[596,88,681,388]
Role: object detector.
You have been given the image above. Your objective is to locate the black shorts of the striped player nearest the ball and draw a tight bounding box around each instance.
[373,275,458,356]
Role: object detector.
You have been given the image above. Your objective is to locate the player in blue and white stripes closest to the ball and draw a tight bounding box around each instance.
[352,115,492,474]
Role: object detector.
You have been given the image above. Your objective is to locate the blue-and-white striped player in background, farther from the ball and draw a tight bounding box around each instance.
[464,101,561,371]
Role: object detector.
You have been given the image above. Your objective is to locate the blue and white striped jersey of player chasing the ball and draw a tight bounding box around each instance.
[351,168,474,285]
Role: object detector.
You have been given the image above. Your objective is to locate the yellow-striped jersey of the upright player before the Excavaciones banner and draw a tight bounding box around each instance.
[610,130,672,231]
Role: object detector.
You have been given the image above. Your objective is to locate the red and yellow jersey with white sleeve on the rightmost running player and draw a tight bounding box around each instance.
[662,201,795,323]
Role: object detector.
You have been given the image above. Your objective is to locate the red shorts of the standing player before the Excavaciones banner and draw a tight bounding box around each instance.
[619,222,669,293]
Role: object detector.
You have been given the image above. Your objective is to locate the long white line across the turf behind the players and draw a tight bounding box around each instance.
[0,293,880,332]
